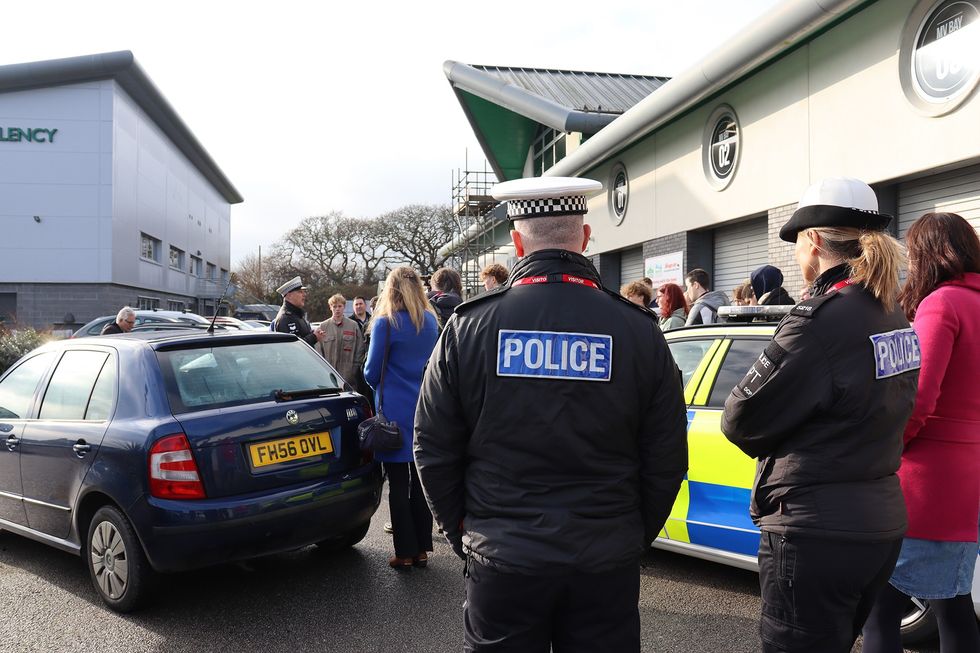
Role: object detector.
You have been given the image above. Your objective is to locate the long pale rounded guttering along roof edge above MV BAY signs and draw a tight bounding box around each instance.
[545,0,876,177]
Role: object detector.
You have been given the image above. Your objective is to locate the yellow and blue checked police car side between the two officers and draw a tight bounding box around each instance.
[660,409,759,556]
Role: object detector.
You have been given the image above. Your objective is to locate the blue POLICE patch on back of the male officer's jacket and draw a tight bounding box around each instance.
[497,329,613,381]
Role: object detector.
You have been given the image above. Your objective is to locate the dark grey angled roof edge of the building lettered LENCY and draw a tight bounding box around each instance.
[0,50,243,204]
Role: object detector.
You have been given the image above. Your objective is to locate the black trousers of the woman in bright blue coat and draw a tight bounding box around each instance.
[384,462,432,558]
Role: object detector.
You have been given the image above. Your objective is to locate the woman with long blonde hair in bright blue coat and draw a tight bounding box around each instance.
[364,267,439,569]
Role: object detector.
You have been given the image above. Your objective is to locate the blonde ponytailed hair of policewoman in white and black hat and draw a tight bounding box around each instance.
[814,227,905,309]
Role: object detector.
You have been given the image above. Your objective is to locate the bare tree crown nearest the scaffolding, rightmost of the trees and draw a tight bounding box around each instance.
[377,204,456,274]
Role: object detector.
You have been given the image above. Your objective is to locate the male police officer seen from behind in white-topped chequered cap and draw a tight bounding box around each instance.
[415,178,687,653]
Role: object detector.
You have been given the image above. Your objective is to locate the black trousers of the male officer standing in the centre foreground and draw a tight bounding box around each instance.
[463,558,640,653]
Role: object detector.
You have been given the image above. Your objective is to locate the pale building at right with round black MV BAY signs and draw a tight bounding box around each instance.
[444,0,980,297]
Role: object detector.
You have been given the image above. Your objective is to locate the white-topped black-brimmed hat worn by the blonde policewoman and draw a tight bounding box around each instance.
[779,177,892,243]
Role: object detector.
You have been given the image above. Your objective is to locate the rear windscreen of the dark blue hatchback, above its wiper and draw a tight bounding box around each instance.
[157,341,344,413]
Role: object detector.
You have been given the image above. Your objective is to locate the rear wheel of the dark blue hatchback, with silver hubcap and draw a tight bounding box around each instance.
[85,506,153,612]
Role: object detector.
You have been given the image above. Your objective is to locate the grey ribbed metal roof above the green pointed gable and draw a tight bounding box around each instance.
[471,64,670,113]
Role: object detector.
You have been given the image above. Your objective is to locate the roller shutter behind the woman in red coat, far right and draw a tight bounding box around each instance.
[898,165,980,239]
